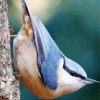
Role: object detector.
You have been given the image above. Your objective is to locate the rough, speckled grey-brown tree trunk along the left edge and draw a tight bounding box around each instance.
[0,0,20,100]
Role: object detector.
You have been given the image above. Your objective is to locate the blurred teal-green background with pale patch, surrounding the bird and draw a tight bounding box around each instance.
[8,0,100,100]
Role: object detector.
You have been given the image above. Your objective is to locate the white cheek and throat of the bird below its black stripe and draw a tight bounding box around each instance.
[57,60,84,91]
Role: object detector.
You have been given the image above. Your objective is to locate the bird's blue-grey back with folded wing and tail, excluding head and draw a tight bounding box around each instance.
[20,0,62,89]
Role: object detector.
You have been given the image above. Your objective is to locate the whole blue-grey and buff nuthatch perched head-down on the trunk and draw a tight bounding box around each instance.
[14,0,100,99]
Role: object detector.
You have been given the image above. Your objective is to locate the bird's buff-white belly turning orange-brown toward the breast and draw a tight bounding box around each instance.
[14,40,57,98]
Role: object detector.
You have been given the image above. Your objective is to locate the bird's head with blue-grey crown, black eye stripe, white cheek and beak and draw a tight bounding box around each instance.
[58,57,100,93]
